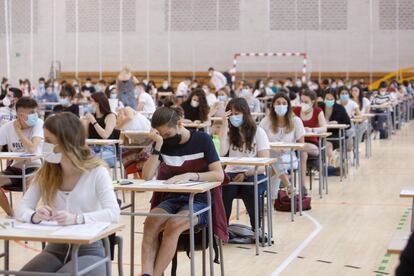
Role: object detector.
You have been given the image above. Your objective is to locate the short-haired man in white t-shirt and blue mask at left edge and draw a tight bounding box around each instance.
[0,97,43,216]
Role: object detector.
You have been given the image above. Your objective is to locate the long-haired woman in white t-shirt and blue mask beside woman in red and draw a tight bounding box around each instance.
[259,93,308,199]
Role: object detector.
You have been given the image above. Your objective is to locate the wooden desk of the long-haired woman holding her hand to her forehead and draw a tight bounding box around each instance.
[220,157,277,255]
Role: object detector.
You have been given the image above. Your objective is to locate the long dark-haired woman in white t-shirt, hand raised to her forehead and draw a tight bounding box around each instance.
[220,98,270,229]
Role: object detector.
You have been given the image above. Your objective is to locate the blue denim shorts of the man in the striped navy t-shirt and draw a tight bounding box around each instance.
[157,195,208,225]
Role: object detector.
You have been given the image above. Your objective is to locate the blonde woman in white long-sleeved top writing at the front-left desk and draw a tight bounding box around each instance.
[16,112,120,276]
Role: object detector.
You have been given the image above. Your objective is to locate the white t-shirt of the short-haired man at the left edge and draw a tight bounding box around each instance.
[0,119,43,169]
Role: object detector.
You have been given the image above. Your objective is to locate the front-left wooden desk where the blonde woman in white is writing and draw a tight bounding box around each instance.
[0,219,124,276]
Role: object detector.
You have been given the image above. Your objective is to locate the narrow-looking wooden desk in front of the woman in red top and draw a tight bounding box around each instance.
[304,132,332,198]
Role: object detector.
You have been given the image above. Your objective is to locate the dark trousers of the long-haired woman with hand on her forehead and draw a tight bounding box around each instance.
[223,173,267,229]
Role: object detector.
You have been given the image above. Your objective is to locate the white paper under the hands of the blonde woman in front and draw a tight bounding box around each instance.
[51,222,110,237]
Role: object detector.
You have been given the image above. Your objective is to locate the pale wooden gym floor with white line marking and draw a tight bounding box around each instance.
[4,123,414,276]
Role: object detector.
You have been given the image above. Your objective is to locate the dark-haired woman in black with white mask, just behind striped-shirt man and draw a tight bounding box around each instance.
[181,88,210,122]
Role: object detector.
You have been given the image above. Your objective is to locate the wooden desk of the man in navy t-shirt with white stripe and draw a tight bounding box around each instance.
[114,179,221,276]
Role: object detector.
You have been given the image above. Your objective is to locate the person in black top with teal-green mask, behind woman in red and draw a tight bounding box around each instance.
[322,89,352,163]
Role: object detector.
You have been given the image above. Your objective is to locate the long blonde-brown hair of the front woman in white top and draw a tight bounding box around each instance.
[34,112,106,206]
